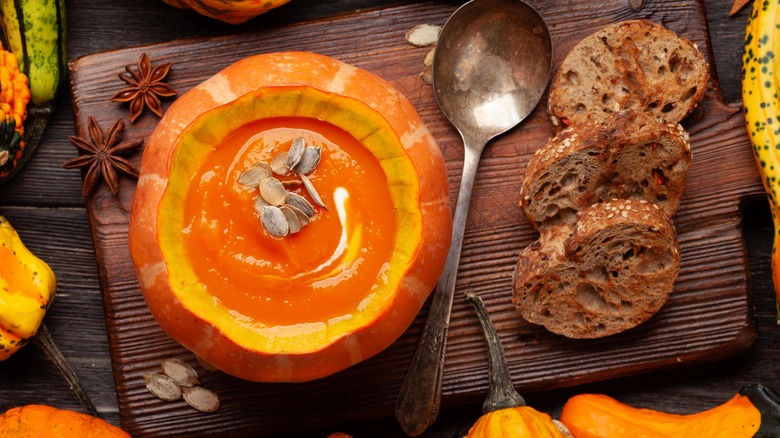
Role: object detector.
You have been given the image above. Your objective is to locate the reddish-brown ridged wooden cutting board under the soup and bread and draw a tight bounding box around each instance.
[70,0,763,437]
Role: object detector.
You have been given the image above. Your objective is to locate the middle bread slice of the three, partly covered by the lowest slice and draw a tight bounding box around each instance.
[520,111,692,229]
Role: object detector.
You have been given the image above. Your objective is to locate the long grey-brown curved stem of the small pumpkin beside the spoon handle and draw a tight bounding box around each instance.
[466,292,525,413]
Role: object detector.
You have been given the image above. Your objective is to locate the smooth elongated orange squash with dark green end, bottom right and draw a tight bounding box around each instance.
[561,385,780,438]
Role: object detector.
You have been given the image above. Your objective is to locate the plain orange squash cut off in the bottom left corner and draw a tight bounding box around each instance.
[0,405,130,438]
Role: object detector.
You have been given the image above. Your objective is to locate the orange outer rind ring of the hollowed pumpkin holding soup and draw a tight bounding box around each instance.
[129,52,452,382]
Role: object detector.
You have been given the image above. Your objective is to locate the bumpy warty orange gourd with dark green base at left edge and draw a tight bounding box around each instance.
[0,45,30,178]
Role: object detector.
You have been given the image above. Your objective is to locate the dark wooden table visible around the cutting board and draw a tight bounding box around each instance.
[0,0,780,437]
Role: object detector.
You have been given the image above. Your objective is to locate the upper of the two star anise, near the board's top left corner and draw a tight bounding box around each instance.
[111,52,176,123]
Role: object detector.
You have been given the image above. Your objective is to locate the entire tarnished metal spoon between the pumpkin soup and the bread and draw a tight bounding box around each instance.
[395,0,552,436]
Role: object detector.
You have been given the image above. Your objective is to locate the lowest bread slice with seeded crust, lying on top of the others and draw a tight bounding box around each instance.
[512,200,680,338]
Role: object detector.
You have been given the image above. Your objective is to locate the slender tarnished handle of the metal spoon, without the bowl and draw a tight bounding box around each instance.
[395,144,484,436]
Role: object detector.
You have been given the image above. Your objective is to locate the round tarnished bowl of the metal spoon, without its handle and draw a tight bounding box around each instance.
[433,0,552,147]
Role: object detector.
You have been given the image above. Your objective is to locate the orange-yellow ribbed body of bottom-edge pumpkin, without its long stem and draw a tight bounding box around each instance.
[467,406,565,438]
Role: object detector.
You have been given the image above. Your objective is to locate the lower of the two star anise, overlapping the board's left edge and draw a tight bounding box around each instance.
[62,116,144,197]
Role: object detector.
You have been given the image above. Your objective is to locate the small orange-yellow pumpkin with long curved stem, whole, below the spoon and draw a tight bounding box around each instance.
[466,292,568,438]
